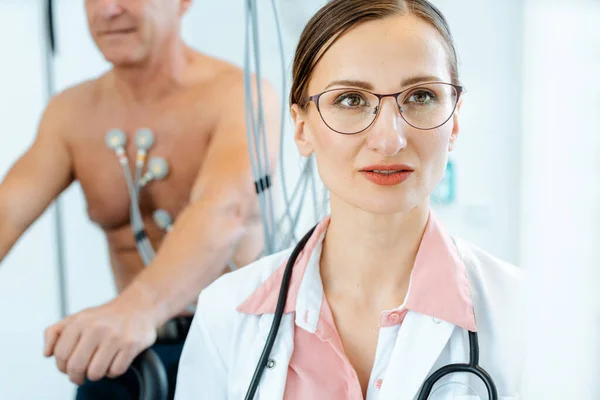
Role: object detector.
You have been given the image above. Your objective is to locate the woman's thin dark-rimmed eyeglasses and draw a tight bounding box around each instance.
[308,82,465,135]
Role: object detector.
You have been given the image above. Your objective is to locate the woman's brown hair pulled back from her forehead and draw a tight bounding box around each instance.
[290,0,460,108]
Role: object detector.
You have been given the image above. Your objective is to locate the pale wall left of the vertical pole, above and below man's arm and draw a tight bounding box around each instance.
[0,0,77,400]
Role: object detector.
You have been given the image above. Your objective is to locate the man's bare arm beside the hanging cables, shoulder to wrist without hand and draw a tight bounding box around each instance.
[125,75,282,324]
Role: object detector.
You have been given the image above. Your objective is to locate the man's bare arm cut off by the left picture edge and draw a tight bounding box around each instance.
[0,95,73,262]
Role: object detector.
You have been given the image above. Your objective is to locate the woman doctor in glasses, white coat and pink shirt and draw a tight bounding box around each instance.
[175,0,522,400]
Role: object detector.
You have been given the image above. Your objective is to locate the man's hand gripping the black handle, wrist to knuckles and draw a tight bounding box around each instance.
[44,284,157,385]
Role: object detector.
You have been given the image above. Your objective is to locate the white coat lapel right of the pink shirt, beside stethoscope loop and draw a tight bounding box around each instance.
[379,311,455,400]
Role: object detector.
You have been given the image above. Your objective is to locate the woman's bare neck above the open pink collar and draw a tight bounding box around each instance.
[321,197,429,308]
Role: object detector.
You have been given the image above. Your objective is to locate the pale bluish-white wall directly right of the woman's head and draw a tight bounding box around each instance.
[433,0,523,263]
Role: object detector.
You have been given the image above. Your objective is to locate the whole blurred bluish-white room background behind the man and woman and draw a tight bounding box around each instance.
[0,0,600,400]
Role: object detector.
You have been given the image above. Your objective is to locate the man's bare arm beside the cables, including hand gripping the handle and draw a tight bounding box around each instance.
[44,73,281,384]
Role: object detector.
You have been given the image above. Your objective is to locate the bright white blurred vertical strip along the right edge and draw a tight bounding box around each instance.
[521,0,600,400]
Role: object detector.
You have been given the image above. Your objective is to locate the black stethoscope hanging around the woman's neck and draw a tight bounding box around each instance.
[245,226,498,400]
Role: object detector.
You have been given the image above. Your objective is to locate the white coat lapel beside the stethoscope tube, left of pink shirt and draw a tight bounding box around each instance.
[255,313,294,400]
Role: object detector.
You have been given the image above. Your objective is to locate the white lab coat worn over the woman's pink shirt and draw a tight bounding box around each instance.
[175,239,523,400]
